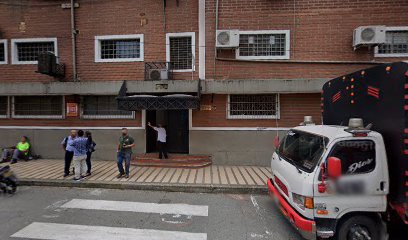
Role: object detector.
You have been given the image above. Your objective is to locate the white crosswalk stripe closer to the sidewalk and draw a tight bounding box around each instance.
[61,199,208,217]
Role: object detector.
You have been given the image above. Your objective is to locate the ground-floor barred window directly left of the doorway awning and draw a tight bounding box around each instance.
[82,96,134,119]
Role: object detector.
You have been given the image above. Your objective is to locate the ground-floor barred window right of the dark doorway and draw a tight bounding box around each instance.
[227,94,279,119]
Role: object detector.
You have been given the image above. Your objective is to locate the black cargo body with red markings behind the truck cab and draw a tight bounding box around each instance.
[321,62,408,222]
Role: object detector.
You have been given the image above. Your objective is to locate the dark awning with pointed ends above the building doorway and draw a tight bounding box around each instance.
[116,81,201,111]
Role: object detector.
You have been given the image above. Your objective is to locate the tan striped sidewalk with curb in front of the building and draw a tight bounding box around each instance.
[0,159,271,193]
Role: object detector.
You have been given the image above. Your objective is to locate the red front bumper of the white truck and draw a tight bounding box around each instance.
[268,179,316,239]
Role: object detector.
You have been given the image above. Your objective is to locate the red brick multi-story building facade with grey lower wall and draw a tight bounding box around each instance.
[0,0,408,165]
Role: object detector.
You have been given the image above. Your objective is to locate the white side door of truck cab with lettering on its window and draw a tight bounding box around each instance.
[314,138,386,218]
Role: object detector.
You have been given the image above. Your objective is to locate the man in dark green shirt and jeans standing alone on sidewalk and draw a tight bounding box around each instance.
[117,128,135,178]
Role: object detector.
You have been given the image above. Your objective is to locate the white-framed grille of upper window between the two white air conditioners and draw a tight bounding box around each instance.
[239,34,287,57]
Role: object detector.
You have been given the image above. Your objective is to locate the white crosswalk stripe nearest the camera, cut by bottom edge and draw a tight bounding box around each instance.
[11,222,207,240]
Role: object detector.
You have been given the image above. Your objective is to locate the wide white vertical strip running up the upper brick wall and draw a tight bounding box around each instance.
[198,0,206,80]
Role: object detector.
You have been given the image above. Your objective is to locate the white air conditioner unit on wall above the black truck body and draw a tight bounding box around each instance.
[353,26,386,48]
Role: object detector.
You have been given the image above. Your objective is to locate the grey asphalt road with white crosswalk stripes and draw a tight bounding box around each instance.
[0,187,301,240]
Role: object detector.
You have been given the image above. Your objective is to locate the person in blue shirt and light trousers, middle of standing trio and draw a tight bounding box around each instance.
[70,130,88,181]
